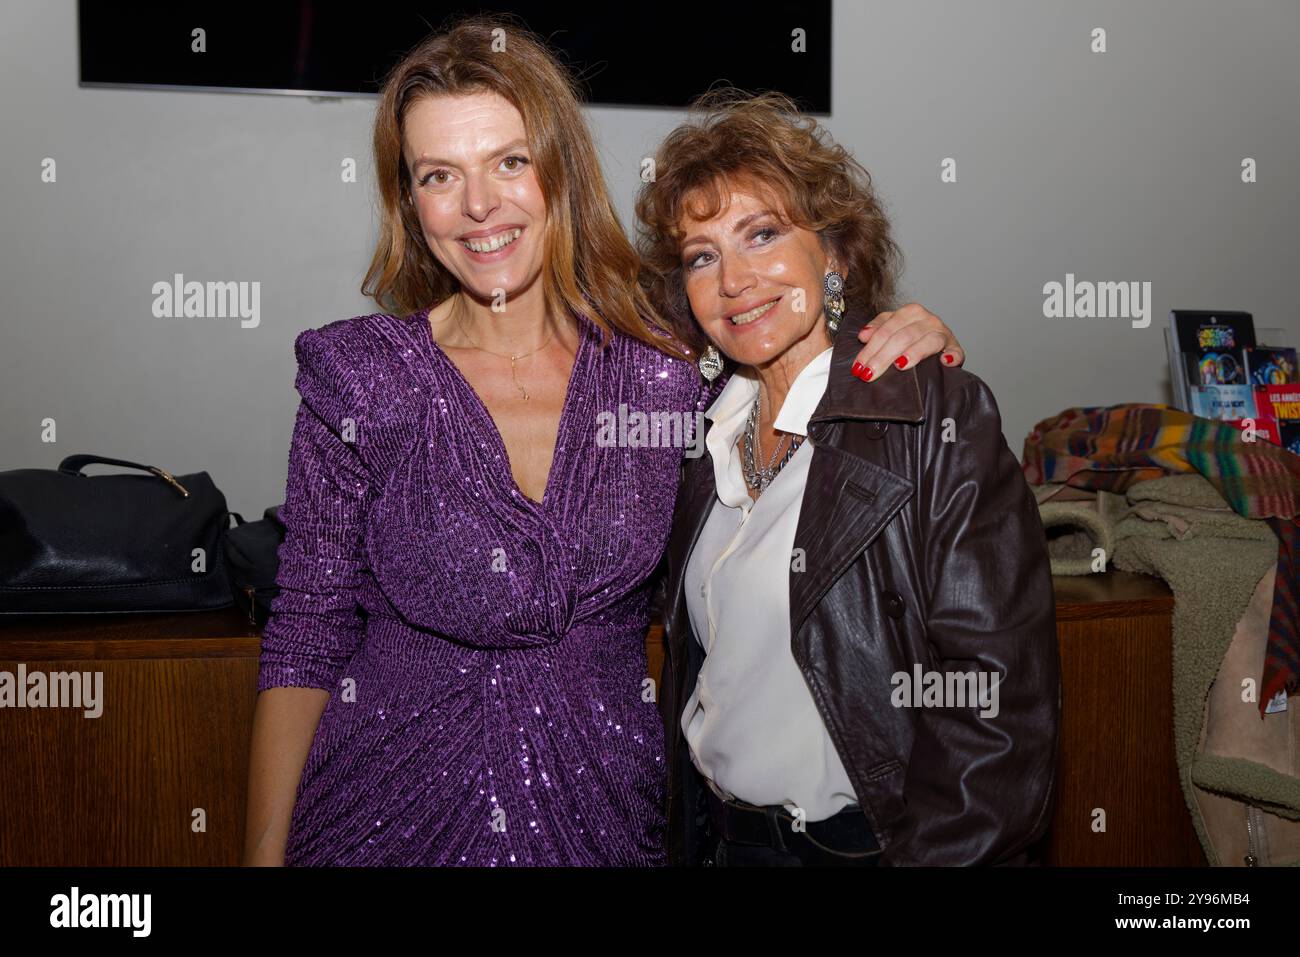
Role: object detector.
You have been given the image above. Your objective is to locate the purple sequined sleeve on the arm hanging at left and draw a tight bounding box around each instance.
[257,329,373,690]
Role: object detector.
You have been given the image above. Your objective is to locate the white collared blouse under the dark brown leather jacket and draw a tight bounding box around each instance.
[681,348,858,820]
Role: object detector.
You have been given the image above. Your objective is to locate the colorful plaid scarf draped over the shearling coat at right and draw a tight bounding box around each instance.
[1022,403,1300,716]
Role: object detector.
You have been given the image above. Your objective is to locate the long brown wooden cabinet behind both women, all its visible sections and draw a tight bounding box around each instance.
[0,572,1204,866]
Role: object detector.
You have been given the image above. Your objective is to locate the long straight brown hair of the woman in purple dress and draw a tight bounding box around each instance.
[361,14,683,355]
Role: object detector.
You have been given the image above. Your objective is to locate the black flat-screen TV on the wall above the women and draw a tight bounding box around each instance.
[77,0,831,113]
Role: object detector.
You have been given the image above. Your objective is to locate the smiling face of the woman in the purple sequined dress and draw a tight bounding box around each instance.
[403,92,546,300]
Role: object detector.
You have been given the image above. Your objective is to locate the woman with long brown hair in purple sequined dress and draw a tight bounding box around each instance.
[246,18,956,865]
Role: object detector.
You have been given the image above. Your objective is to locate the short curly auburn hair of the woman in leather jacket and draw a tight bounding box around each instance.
[636,87,902,350]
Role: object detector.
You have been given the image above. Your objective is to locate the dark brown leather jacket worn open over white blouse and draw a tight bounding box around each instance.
[659,312,1061,865]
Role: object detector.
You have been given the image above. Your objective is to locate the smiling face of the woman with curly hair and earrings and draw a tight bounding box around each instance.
[679,180,835,368]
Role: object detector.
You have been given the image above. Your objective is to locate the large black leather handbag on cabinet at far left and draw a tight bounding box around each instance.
[0,455,234,615]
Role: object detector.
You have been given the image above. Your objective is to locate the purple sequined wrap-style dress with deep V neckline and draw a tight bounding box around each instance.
[257,311,703,865]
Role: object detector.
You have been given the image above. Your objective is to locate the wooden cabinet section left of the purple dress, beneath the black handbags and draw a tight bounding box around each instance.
[0,610,261,866]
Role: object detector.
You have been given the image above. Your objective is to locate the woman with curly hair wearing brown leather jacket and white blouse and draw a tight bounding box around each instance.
[637,91,1060,866]
